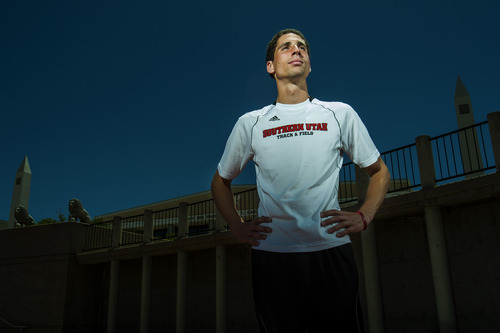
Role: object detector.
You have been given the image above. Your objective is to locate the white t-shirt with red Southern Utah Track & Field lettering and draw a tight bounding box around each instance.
[218,99,380,252]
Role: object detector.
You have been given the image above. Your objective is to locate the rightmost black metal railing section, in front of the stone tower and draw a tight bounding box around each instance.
[431,121,495,184]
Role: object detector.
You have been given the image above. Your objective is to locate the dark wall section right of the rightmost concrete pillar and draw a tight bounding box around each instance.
[444,199,500,332]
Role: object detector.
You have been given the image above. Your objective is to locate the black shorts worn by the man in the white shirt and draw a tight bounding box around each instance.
[252,244,363,333]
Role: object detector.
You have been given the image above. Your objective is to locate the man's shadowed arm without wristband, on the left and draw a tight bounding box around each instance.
[212,171,272,246]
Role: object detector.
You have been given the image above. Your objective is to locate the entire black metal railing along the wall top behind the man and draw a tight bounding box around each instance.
[83,122,495,251]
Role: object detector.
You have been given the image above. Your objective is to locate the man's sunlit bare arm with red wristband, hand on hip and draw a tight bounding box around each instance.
[321,157,391,237]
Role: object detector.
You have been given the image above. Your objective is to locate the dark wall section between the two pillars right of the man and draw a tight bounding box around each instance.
[374,214,438,332]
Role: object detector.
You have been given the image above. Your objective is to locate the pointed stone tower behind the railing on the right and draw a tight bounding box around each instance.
[455,75,483,178]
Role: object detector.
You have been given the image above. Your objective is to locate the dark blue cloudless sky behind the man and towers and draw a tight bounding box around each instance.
[0,0,500,221]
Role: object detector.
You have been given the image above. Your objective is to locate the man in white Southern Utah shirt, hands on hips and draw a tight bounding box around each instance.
[212,29,390,333]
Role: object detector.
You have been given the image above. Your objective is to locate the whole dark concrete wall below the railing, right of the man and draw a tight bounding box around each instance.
[368,174,500,332]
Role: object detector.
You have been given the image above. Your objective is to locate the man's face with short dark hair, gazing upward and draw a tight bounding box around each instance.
[267,33,311,80]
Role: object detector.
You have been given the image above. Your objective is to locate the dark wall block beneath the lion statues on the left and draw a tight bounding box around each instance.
[0,222,103,333]
